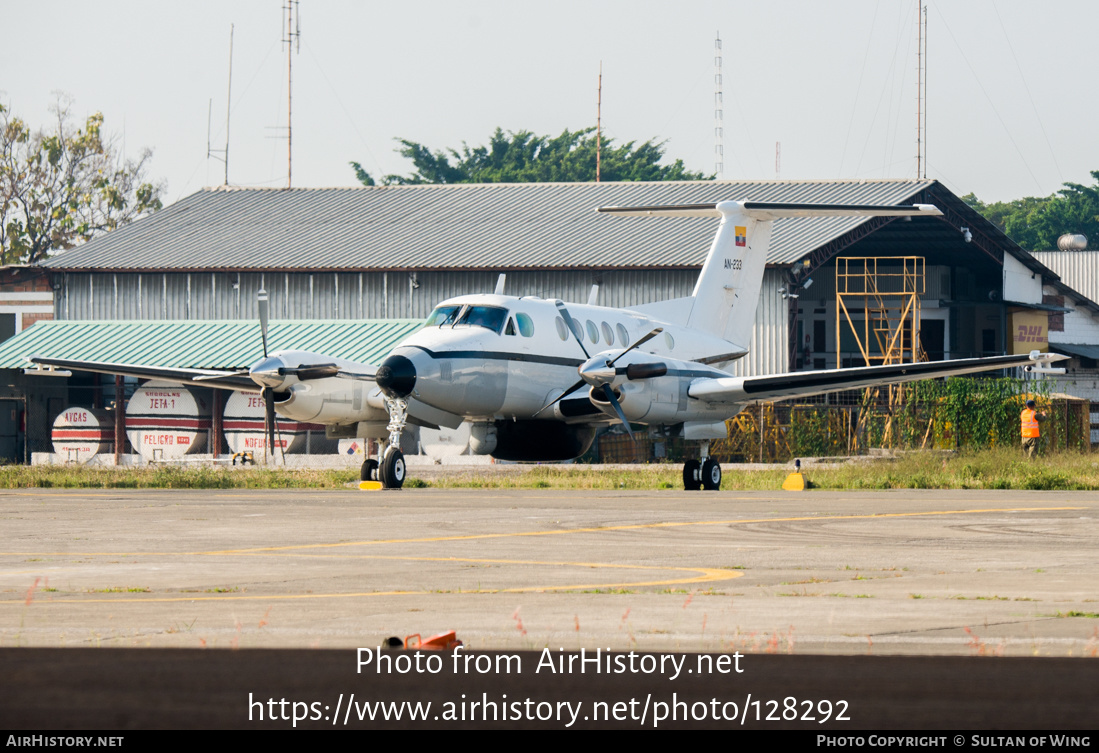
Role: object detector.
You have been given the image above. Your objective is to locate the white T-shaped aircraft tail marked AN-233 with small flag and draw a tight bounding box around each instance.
[597,201,942,348]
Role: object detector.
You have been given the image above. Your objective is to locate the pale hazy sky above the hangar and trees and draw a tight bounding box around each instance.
[0,0,1099,201]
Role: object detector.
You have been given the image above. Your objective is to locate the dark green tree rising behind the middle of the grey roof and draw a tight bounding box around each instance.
[351,129,712,186]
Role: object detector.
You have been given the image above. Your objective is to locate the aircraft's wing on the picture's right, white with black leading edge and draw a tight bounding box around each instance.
[687,352,1068,403]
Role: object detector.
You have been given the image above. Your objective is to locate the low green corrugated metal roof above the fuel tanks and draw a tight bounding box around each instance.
[0,319,423,368]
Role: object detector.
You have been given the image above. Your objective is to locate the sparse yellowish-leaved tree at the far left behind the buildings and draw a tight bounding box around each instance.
[0,99,164,264]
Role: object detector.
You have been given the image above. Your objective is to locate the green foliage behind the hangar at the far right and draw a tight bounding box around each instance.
[962,170,1099,251]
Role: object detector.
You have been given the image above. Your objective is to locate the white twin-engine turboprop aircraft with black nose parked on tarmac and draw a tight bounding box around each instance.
[31,201,1064,489]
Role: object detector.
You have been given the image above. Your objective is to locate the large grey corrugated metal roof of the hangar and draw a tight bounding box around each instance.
[45,180,935,272]
